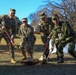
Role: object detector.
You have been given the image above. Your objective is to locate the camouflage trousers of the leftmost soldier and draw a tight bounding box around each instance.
[0,32,14,58]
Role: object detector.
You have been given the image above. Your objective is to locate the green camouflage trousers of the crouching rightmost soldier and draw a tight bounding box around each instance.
[56,41,76,58]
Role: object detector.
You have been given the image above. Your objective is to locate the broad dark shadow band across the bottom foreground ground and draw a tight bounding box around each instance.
[0,63,76,75]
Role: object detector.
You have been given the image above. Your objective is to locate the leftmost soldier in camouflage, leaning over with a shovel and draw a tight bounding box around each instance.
[0,9,16,63]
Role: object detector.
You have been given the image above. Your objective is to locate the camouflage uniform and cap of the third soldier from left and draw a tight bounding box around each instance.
[40,12,53,58]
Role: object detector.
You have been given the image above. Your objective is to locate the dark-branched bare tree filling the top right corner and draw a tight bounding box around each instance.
[45,0,76,27]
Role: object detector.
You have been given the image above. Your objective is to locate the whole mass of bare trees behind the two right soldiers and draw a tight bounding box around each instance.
[30,0,76,29]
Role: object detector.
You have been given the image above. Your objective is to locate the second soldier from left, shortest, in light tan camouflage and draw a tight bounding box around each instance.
[19,18,36,60]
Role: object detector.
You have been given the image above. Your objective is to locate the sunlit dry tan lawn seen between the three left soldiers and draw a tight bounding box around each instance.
[0,35,43,61]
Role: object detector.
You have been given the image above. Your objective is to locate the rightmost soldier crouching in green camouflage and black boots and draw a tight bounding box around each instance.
[49,14,76,63]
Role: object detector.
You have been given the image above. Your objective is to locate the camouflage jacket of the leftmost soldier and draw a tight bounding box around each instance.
[0,15,16,36]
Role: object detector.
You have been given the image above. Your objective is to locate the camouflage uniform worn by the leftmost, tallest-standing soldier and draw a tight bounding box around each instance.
[0,10,16,59]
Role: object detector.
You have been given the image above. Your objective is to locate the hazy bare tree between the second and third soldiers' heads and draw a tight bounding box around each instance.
[29,7,51,31]
